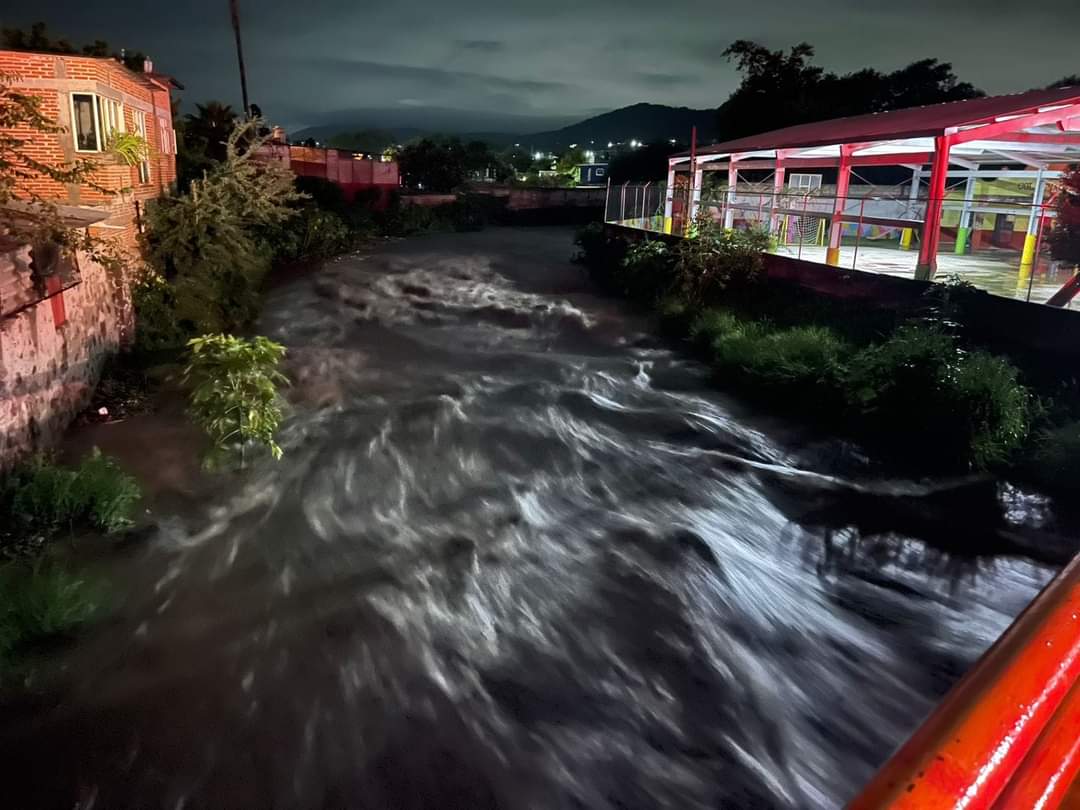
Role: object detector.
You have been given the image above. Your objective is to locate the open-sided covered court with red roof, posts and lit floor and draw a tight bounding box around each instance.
[635,87,1080,300]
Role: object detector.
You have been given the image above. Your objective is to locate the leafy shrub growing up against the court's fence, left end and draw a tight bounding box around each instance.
[675,210,769,306]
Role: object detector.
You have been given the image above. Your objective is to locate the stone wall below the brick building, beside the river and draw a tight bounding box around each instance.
[0,247,132,467]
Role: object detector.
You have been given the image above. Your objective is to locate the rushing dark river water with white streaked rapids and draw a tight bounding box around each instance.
[0,230,1052,810]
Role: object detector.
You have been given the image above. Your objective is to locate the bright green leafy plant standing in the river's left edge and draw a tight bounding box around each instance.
[184,335,287,467]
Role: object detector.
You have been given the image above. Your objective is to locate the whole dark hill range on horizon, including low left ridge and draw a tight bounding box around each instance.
[291,103,716,152]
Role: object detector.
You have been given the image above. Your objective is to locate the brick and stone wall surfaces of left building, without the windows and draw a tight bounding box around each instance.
[0,51,176,465]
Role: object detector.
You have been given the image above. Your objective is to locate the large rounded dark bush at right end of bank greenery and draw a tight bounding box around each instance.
[847,326,1030,469]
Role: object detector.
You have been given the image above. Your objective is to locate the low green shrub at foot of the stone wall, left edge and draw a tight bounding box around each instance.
[2,448,141,532]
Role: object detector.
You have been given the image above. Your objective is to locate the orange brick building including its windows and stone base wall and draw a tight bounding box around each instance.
[0,51,176,463]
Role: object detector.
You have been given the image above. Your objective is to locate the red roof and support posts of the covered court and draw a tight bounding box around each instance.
[664,87,1080,279]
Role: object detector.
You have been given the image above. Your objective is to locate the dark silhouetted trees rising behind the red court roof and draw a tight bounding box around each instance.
[717,40,983,139]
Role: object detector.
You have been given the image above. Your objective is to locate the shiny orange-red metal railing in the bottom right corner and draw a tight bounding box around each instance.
[849,557,1080,810]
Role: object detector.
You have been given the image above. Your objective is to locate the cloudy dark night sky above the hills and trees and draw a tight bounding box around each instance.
[0,0,1080,132]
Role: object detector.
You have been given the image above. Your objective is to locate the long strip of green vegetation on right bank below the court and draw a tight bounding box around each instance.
[578,222,1036,472]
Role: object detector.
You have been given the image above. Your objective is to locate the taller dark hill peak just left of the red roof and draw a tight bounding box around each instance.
[519,103,716,152]
